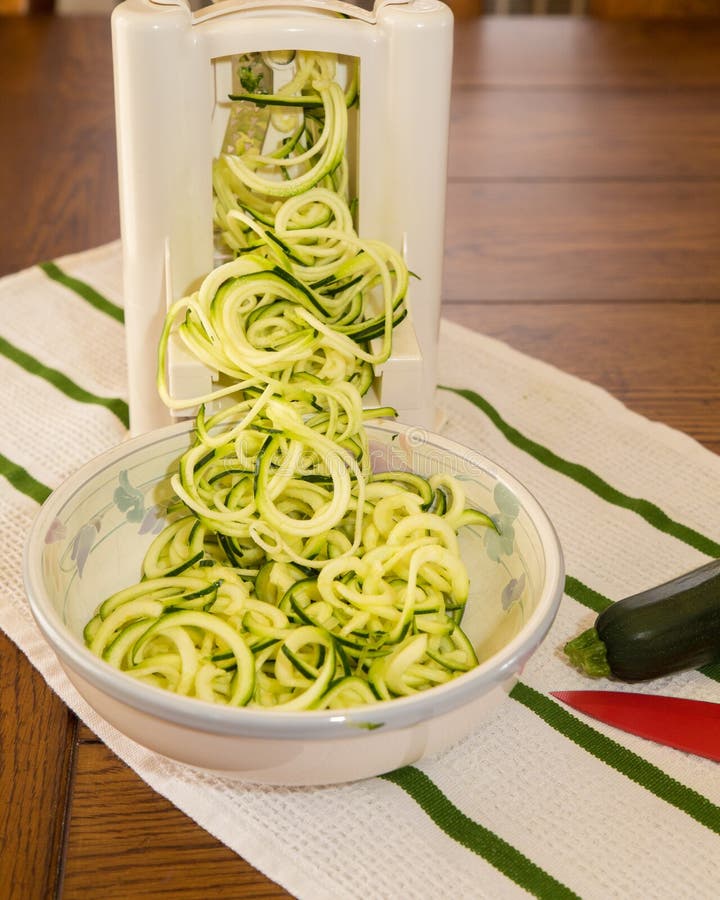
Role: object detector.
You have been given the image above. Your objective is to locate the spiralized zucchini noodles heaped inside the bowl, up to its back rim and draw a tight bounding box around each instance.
[84,400,496,709]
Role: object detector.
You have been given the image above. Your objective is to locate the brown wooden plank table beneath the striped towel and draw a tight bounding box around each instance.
[0,17,720,900]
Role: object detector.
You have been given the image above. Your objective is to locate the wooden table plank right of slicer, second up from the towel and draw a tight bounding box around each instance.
[445,180,720,302]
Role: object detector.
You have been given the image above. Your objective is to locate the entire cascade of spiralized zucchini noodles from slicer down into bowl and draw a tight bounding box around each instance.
[85,52,492,710]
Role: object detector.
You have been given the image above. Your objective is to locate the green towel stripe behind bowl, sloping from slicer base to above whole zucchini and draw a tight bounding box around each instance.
[443,386,720,557]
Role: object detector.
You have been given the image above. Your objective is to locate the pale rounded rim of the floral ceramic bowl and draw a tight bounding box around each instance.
[22,419,564,740]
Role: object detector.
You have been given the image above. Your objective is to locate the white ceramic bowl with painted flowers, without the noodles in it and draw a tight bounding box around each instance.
[24,422,564,785]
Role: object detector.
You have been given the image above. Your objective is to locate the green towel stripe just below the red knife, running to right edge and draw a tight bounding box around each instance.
[510,682,720,834]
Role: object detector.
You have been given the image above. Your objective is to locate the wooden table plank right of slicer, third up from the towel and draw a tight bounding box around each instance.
[449,88,720,181]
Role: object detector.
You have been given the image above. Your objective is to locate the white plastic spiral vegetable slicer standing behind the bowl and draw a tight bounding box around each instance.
[112,0,452,433]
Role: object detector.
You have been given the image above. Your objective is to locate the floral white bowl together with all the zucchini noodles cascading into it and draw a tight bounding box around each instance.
[25,47,563,784]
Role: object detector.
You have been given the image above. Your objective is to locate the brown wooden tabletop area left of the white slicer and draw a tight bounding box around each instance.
[0,16,120,275]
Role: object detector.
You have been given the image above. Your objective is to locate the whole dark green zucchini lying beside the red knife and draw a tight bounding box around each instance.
[565,559,720,681]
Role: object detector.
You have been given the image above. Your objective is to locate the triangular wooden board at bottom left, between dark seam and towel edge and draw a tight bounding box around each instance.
[62,743,289,900]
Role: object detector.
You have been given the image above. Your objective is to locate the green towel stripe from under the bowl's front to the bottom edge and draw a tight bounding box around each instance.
[380,766,577,900]
